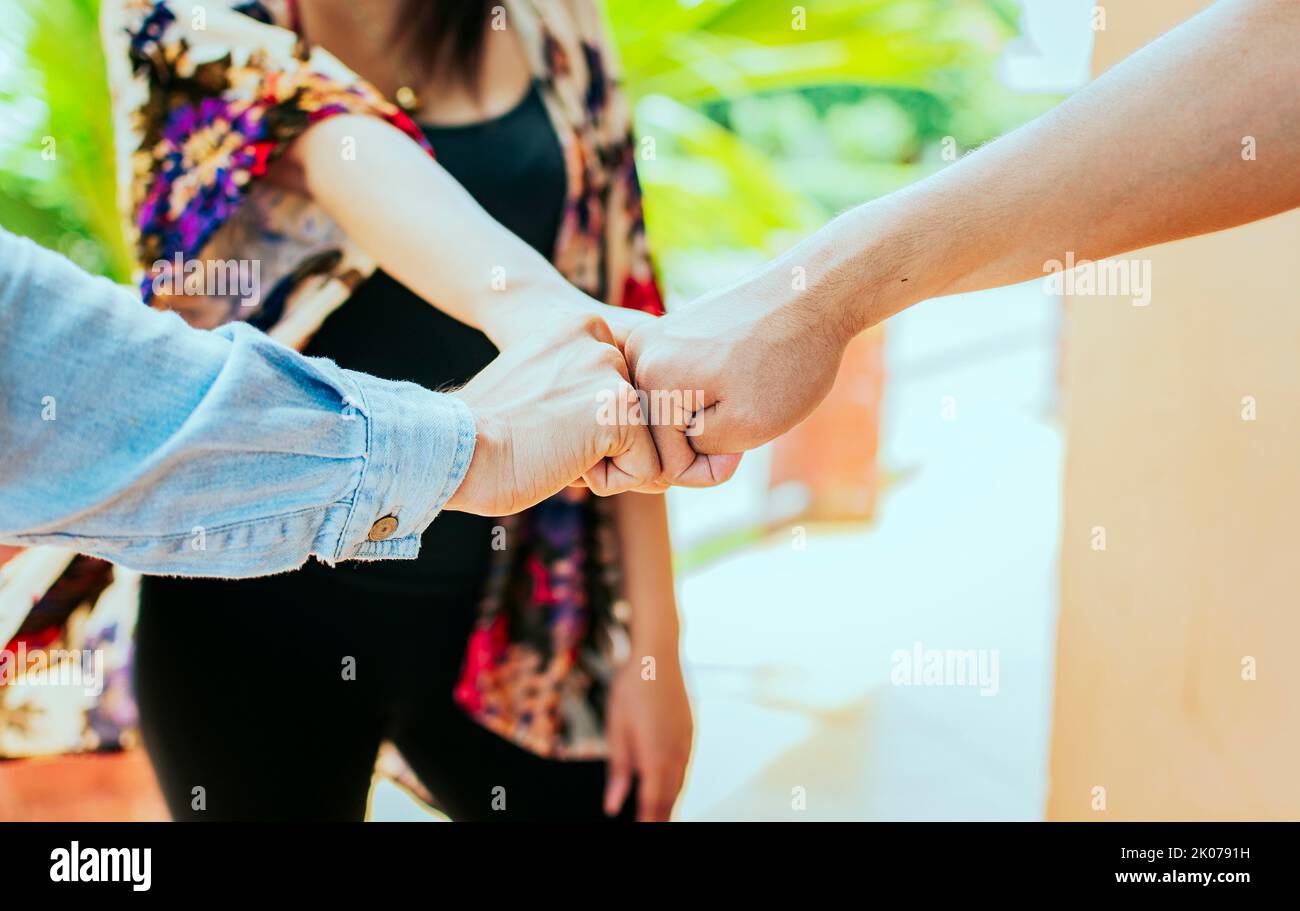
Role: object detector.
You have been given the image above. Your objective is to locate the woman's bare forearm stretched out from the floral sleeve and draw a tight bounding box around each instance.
[270,114,650,347]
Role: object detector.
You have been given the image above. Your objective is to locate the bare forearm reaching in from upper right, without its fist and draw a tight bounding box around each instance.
[766,0,1300,335]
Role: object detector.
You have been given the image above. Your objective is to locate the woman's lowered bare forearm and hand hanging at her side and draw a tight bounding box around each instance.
[605,494,692,821]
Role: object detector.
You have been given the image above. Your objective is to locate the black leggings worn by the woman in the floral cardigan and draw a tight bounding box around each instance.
[135,569,636,820]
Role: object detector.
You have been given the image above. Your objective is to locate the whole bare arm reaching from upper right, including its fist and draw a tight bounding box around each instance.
[628,0,1300,462]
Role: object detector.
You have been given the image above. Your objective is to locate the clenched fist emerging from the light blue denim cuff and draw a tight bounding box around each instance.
[446,316,659,516]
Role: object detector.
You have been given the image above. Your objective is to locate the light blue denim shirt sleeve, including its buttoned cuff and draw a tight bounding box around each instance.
[0,230,476,577]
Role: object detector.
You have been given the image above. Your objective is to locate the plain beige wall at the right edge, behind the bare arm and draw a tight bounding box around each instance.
[1048,0,1300,820]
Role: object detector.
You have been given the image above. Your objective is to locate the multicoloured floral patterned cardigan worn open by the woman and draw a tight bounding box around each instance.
[0,0,662,758]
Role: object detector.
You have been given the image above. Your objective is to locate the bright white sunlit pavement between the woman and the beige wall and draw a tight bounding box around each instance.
[673,280,1062,819]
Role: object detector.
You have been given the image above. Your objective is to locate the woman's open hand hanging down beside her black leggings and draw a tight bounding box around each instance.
[605,659,693,823]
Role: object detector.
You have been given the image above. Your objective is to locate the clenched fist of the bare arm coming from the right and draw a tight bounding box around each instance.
[624,274,850,486]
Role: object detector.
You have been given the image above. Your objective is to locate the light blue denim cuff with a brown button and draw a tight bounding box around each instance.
[325,374,477,560]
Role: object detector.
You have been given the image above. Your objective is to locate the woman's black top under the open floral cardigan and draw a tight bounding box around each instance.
[304,83,566,598]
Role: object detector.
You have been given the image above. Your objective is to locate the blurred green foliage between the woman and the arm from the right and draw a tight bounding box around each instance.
[607,0,1058,265]
